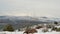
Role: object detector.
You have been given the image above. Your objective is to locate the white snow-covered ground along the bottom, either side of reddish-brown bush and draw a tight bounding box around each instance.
[0,29,60,34]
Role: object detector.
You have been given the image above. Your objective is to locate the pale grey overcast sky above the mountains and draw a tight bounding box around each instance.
[0,0,60,17]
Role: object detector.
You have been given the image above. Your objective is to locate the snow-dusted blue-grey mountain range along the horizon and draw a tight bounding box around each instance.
[0,16,60,24]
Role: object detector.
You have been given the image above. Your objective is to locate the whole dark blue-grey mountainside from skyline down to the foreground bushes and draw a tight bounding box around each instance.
[0,16,60,28]
